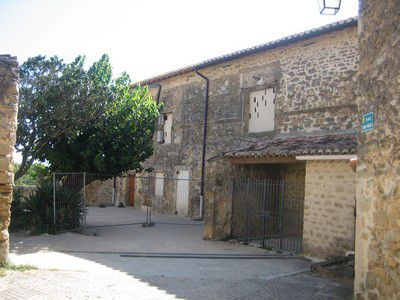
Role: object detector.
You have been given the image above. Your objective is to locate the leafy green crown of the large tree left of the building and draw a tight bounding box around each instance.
[16,55,158,179]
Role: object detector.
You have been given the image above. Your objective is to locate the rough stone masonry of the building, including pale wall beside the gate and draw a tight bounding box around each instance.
[141,20,358,257]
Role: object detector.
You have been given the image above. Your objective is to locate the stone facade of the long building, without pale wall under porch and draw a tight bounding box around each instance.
[146,25,358,227]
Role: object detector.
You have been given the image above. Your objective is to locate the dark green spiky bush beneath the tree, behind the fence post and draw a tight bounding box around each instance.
[11,180,86,234]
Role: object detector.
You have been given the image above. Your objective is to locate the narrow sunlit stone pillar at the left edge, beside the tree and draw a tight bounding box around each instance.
[0,55,18,262]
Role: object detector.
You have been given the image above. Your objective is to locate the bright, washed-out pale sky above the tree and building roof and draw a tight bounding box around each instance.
[0,0,358,81]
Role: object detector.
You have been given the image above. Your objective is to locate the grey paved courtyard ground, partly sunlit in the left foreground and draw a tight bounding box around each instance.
[0,208,352,299]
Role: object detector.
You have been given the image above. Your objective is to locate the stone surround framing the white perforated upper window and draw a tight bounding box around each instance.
[240,80,279,136]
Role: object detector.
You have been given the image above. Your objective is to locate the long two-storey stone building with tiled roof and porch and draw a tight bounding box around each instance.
[138,19,359,257]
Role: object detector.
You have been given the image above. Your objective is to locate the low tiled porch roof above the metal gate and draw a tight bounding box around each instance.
[219,134,357,158]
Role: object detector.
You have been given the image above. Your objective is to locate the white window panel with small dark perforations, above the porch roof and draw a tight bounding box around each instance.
[249,89,275,132]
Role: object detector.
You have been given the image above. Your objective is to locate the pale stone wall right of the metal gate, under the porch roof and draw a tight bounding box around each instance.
[303,160,356,258]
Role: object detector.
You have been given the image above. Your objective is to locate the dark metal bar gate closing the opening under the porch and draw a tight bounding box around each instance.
[231,178,304,253]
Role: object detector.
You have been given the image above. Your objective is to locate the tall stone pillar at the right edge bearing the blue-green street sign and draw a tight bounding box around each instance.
[354,0,400,299]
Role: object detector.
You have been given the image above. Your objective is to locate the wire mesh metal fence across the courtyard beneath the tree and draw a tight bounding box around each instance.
[53,172,200,231]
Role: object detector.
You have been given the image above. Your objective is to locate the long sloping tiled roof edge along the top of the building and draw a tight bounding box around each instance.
[134,17,357,85]
